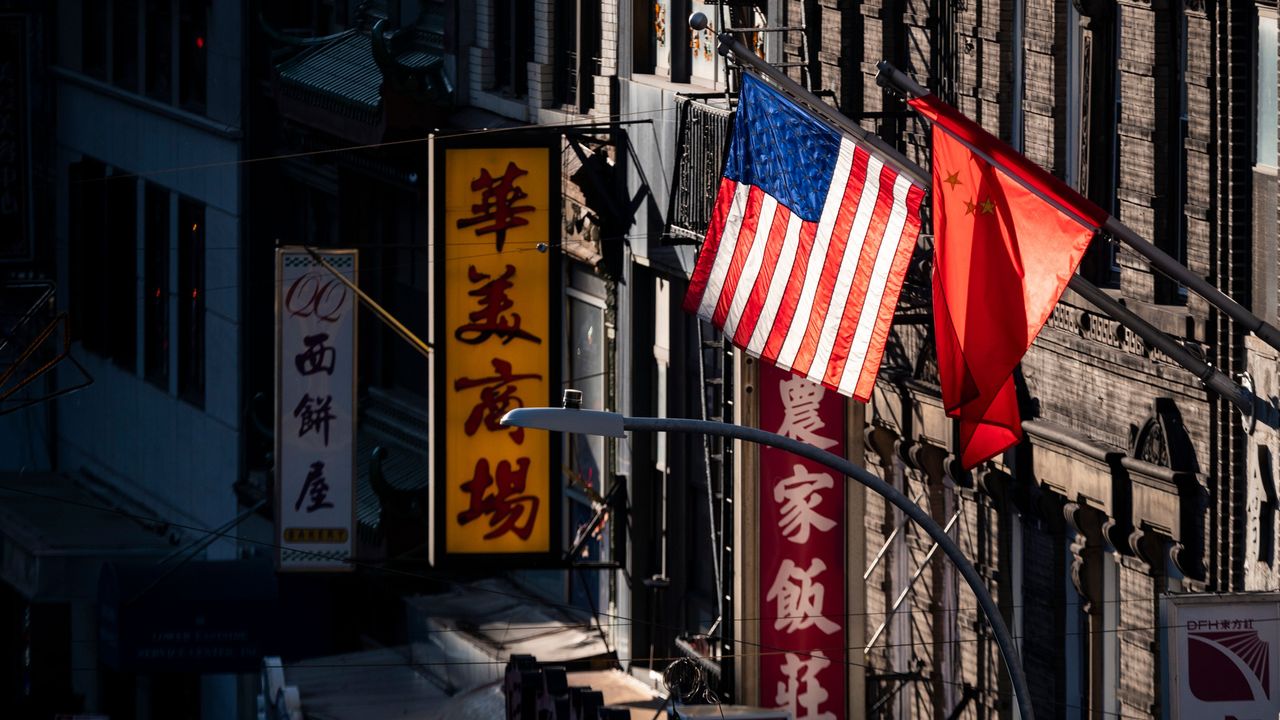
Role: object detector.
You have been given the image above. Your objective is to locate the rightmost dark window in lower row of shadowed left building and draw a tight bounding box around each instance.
[175,197,205,407]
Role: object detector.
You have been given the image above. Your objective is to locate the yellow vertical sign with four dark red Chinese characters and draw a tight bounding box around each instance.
[436,147,557,555]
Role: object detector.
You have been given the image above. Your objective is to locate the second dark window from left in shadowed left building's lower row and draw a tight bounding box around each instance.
[106,173,138,373]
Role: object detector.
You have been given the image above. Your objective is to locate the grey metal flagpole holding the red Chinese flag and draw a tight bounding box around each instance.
[876,60,1280,350]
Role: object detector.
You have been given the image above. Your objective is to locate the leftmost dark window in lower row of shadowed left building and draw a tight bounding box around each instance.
[67,159,106,354]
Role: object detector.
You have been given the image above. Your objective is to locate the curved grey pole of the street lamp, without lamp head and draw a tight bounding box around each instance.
[622,418,1034,720]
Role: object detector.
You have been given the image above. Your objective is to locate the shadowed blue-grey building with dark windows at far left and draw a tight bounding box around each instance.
[0,0,254,716]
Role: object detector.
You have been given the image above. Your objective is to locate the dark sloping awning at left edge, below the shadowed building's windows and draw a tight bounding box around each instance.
[0,473,173,601]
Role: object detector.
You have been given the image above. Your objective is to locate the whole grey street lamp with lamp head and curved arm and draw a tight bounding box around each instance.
[502,389,1034,720]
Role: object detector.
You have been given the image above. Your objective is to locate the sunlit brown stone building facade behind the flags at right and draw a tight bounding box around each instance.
[757,0,1277,719]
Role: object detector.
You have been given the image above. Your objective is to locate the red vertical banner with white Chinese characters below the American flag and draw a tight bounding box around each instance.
[759,363,849,720]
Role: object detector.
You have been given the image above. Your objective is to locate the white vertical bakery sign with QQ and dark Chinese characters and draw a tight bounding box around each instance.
[275,247,357,570]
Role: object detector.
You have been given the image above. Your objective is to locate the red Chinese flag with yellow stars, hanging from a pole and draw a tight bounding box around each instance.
[910,95,1107,469]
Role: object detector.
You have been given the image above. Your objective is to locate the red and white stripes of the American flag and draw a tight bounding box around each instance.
[685,137,924,402]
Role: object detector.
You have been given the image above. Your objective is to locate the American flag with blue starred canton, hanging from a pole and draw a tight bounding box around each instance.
[685,73,924,402]
